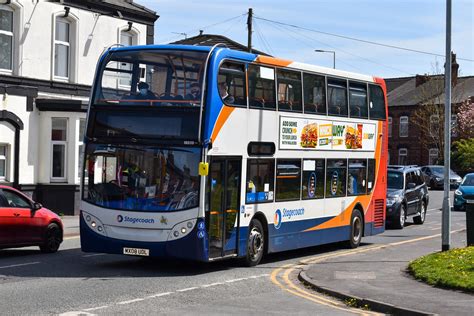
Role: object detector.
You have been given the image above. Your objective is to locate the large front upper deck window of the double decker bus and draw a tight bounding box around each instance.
[93,50,207,106]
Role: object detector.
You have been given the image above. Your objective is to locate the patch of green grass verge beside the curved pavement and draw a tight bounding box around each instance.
[408,246,474,293]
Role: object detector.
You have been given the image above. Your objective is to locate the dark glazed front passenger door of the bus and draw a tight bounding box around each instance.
[206,157,242,259]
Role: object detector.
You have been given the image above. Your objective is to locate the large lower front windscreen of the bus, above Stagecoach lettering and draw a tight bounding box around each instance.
[83,144,201,212]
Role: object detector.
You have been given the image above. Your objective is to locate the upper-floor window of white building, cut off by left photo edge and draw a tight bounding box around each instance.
[0,9,13,71]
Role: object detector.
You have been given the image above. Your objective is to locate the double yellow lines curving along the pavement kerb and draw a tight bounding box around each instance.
[270,229,465,315]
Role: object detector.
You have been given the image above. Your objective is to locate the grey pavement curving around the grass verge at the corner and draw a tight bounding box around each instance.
[299,230,474,315]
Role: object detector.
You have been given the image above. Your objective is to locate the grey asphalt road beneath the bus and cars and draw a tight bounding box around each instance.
[0,191,465,315]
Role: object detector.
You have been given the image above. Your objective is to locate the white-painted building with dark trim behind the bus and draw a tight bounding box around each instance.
[0,0,158,214]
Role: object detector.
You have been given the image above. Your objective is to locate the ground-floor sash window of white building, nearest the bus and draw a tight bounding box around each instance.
[51,118,67,181]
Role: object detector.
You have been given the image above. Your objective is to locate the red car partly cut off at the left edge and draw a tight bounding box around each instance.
[0,185,63,253]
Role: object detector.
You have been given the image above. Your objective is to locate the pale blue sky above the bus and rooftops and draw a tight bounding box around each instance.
[135,0,474,78]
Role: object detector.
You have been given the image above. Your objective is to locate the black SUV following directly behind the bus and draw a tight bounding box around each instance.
[386,166,429,229]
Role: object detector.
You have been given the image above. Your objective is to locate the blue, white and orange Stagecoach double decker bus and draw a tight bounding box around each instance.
[80,45,388,266]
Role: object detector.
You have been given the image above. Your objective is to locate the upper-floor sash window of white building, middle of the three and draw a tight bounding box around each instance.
[54,18,71,79]
